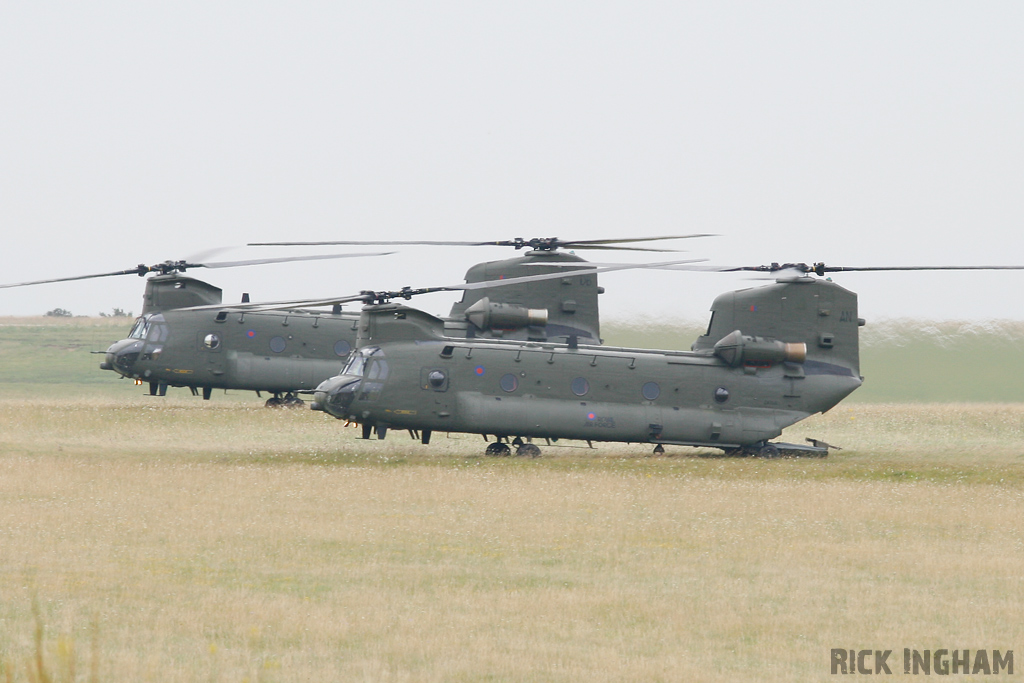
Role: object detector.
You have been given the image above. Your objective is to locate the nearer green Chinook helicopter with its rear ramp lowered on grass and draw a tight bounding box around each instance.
[286,263,1024,458]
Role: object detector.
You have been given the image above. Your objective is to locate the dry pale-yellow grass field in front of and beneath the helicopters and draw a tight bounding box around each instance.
[0,398,1024,681]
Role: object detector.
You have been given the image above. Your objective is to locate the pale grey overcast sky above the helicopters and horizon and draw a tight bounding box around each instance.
[0,0,1024,321]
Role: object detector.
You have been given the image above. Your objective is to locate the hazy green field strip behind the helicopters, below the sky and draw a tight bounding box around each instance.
[0,315,1024,402]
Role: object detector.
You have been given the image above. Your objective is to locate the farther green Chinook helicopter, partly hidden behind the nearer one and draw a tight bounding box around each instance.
[0,236,703,405]
